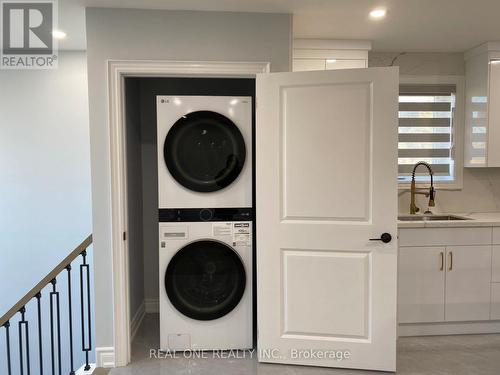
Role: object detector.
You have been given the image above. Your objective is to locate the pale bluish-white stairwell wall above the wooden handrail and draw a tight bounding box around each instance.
[0,52,92,315]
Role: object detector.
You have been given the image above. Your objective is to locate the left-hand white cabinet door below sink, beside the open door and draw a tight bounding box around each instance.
[398,247,446,323]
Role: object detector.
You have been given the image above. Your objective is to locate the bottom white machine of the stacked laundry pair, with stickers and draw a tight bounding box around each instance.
[160,219,253,351]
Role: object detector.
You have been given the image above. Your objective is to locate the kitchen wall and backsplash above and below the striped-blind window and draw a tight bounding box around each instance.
[369,52,500,213]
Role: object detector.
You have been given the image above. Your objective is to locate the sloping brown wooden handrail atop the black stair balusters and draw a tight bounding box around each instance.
[0,235,92,327]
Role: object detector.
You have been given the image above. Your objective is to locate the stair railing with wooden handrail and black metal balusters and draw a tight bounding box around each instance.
[0,235,92,375]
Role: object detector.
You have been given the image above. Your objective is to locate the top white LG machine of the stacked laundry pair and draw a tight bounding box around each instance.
[157,96,252,209]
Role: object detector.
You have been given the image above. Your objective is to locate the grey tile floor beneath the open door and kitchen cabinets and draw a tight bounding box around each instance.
[110,314,500,375]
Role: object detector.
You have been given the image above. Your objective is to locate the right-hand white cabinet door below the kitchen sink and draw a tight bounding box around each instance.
[445,246,491,321]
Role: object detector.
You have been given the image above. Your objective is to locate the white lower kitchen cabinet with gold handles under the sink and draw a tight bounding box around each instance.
[398,226,500,336]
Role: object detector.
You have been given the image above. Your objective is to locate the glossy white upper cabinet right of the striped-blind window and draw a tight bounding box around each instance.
[464,42,500,167]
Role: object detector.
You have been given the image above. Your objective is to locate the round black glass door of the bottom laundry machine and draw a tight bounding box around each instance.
[165,240,246,320]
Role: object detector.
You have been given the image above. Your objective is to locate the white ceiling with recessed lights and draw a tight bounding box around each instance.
[59,0,500,52]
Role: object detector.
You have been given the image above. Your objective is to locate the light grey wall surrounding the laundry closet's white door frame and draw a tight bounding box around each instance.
[87,8,292,347]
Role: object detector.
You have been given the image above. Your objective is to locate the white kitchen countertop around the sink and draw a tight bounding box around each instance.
[398,212,500,228]
